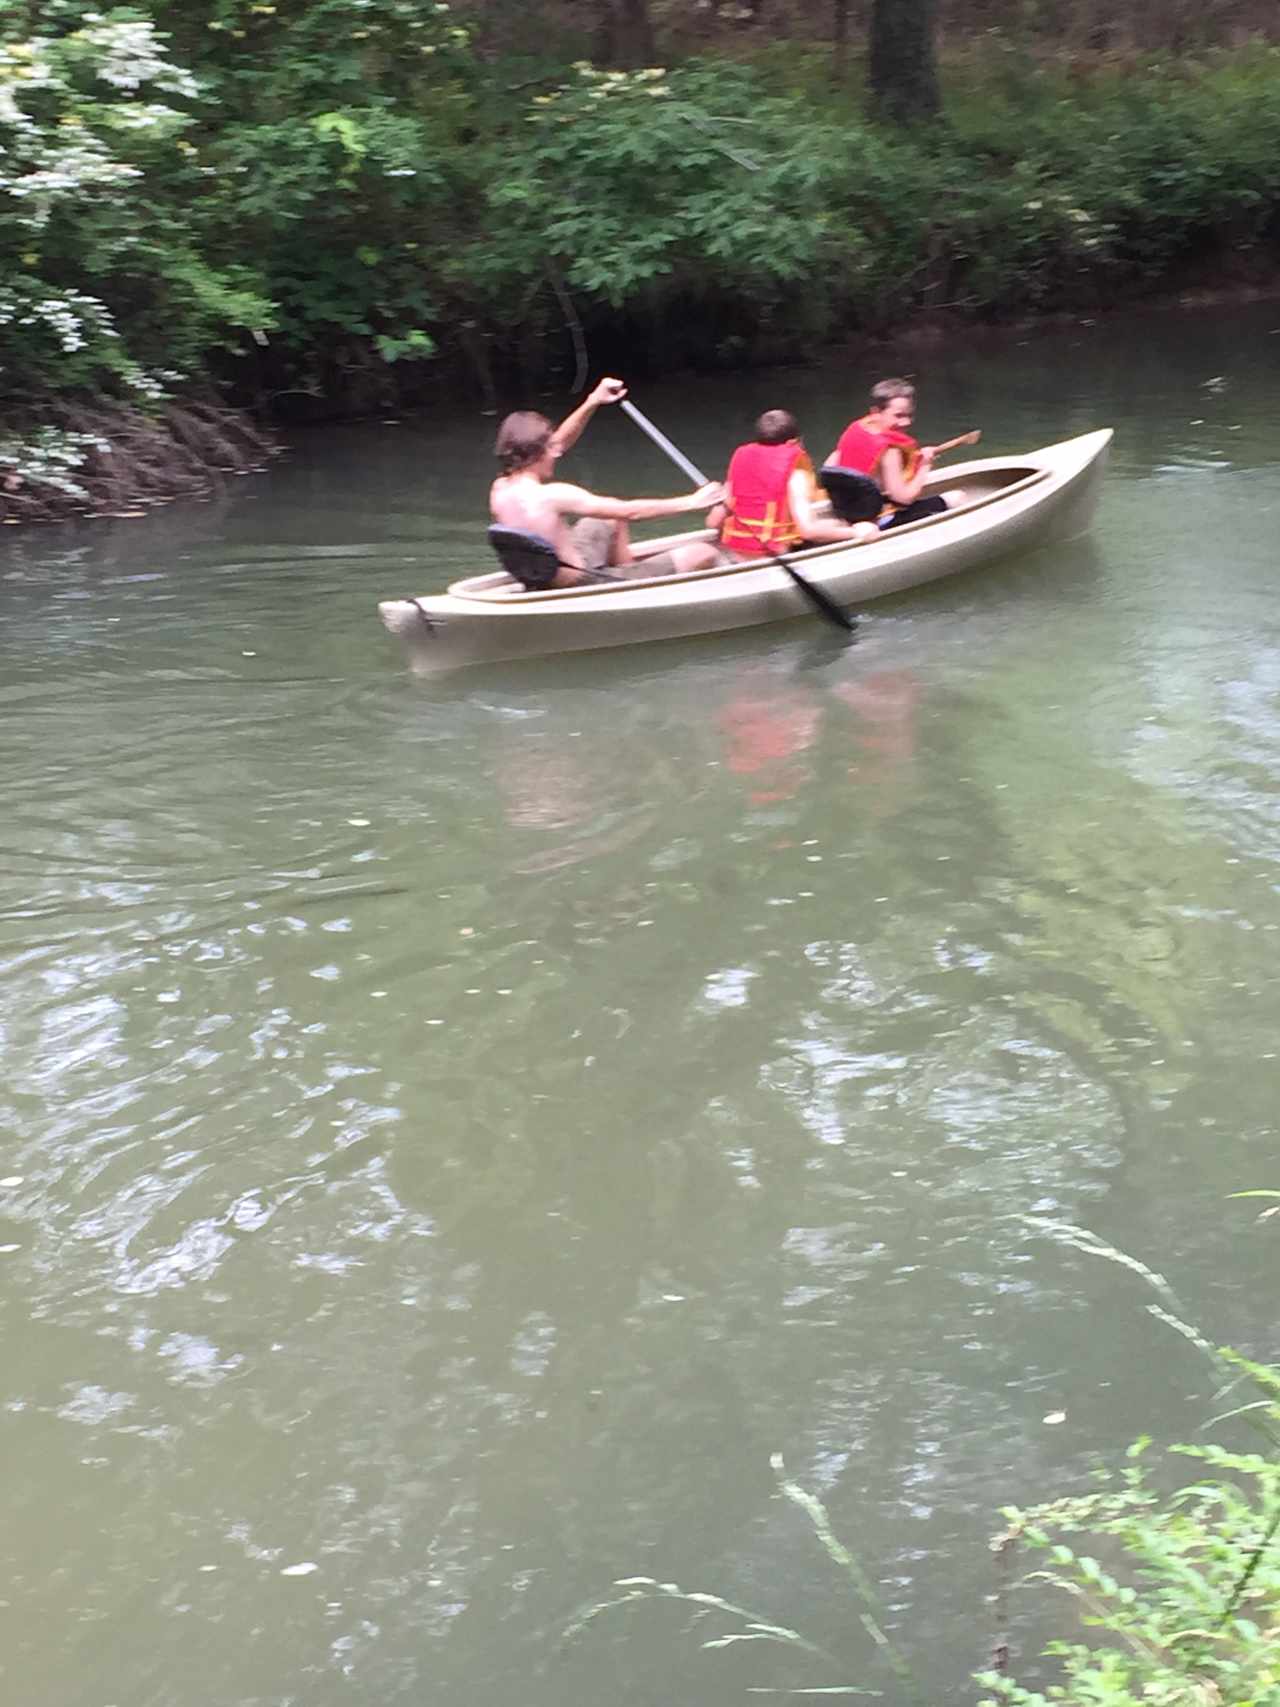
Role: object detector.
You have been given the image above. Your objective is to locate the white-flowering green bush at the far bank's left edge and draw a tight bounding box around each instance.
[0,7,271,399]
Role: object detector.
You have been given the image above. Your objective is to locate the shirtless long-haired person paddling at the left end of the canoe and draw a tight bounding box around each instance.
[488,379,722,591]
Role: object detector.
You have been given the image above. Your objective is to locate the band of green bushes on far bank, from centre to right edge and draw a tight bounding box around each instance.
[456,51,1280,361]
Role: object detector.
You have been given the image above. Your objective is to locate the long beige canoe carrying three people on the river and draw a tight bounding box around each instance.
[377,428,1111,669]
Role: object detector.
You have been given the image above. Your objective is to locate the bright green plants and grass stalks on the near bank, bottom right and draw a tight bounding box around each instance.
[560,1215,1280,1707]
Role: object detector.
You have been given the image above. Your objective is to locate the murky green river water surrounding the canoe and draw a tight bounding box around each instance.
[0,306,1280,1707]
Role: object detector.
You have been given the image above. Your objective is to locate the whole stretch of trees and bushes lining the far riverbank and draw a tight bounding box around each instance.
[0,0,1280,524]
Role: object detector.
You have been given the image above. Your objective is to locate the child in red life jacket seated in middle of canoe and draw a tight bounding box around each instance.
[708,410,879,562]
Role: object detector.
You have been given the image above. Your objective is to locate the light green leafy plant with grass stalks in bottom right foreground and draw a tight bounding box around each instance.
[565,1215,1280,1707]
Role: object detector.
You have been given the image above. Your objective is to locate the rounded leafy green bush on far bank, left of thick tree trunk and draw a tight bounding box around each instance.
[456,63,928,358]
